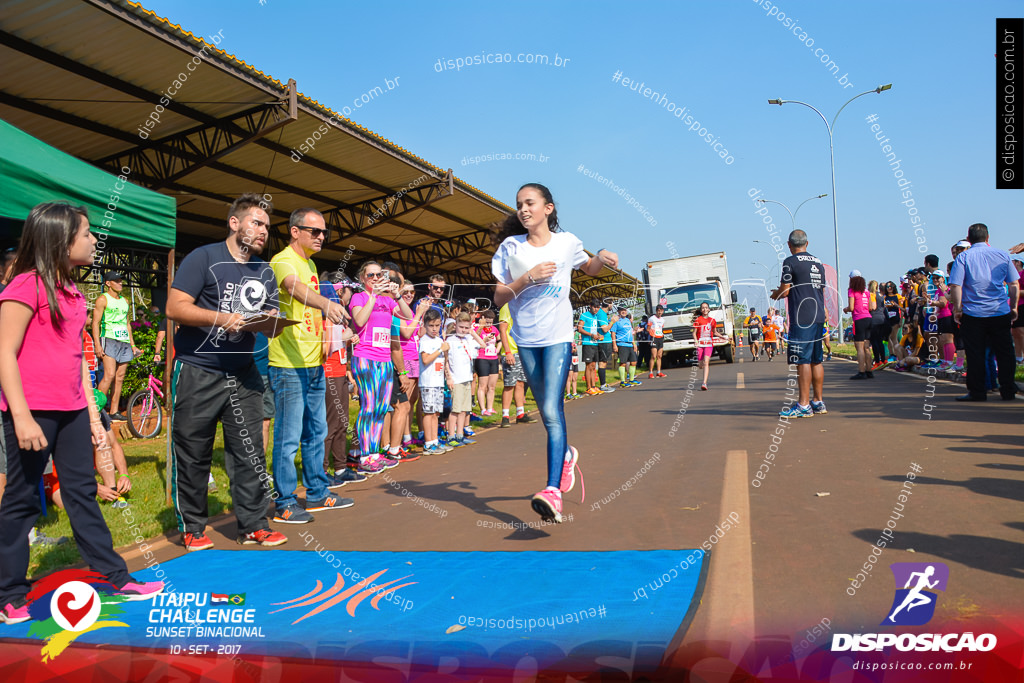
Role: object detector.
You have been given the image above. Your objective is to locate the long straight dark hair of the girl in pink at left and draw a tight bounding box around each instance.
[10,202,89,328]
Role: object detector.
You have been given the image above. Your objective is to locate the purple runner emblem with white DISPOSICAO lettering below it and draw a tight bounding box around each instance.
[831,562,996,652]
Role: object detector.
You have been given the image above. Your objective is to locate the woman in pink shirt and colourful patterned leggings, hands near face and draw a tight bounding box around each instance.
[348,261,413,474]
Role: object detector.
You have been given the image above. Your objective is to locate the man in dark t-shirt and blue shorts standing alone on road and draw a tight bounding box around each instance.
[771,230,828,418]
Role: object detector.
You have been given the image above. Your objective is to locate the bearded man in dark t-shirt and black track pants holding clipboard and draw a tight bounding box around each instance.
[167,195,287,551]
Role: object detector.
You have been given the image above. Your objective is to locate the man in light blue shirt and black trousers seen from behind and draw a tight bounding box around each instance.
[949,223,1020,400]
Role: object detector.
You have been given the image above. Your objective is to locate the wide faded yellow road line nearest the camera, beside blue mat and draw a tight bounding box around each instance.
[706,451,755,661]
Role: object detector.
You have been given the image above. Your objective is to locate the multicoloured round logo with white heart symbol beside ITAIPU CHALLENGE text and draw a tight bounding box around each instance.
[27,569,128,663]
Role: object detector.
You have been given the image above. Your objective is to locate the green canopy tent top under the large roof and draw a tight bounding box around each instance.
[0,120,177,249]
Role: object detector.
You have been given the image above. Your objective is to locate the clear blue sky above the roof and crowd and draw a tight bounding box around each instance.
[143,0,1024,305]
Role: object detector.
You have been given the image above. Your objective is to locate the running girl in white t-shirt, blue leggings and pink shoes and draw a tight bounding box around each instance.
[490,182,618,522]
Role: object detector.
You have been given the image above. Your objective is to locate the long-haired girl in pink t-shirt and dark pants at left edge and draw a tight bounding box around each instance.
[0,202,164,624]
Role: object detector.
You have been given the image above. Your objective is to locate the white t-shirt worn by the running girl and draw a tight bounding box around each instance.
[490,232,590,348]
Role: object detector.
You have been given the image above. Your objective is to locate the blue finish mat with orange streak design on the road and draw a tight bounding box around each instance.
[0,550,708,670]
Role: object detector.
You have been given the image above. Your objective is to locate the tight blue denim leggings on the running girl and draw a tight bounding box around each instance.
[519,342,572,487]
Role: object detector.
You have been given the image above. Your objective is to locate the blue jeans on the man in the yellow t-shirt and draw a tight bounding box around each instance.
[269,366,328,510]
